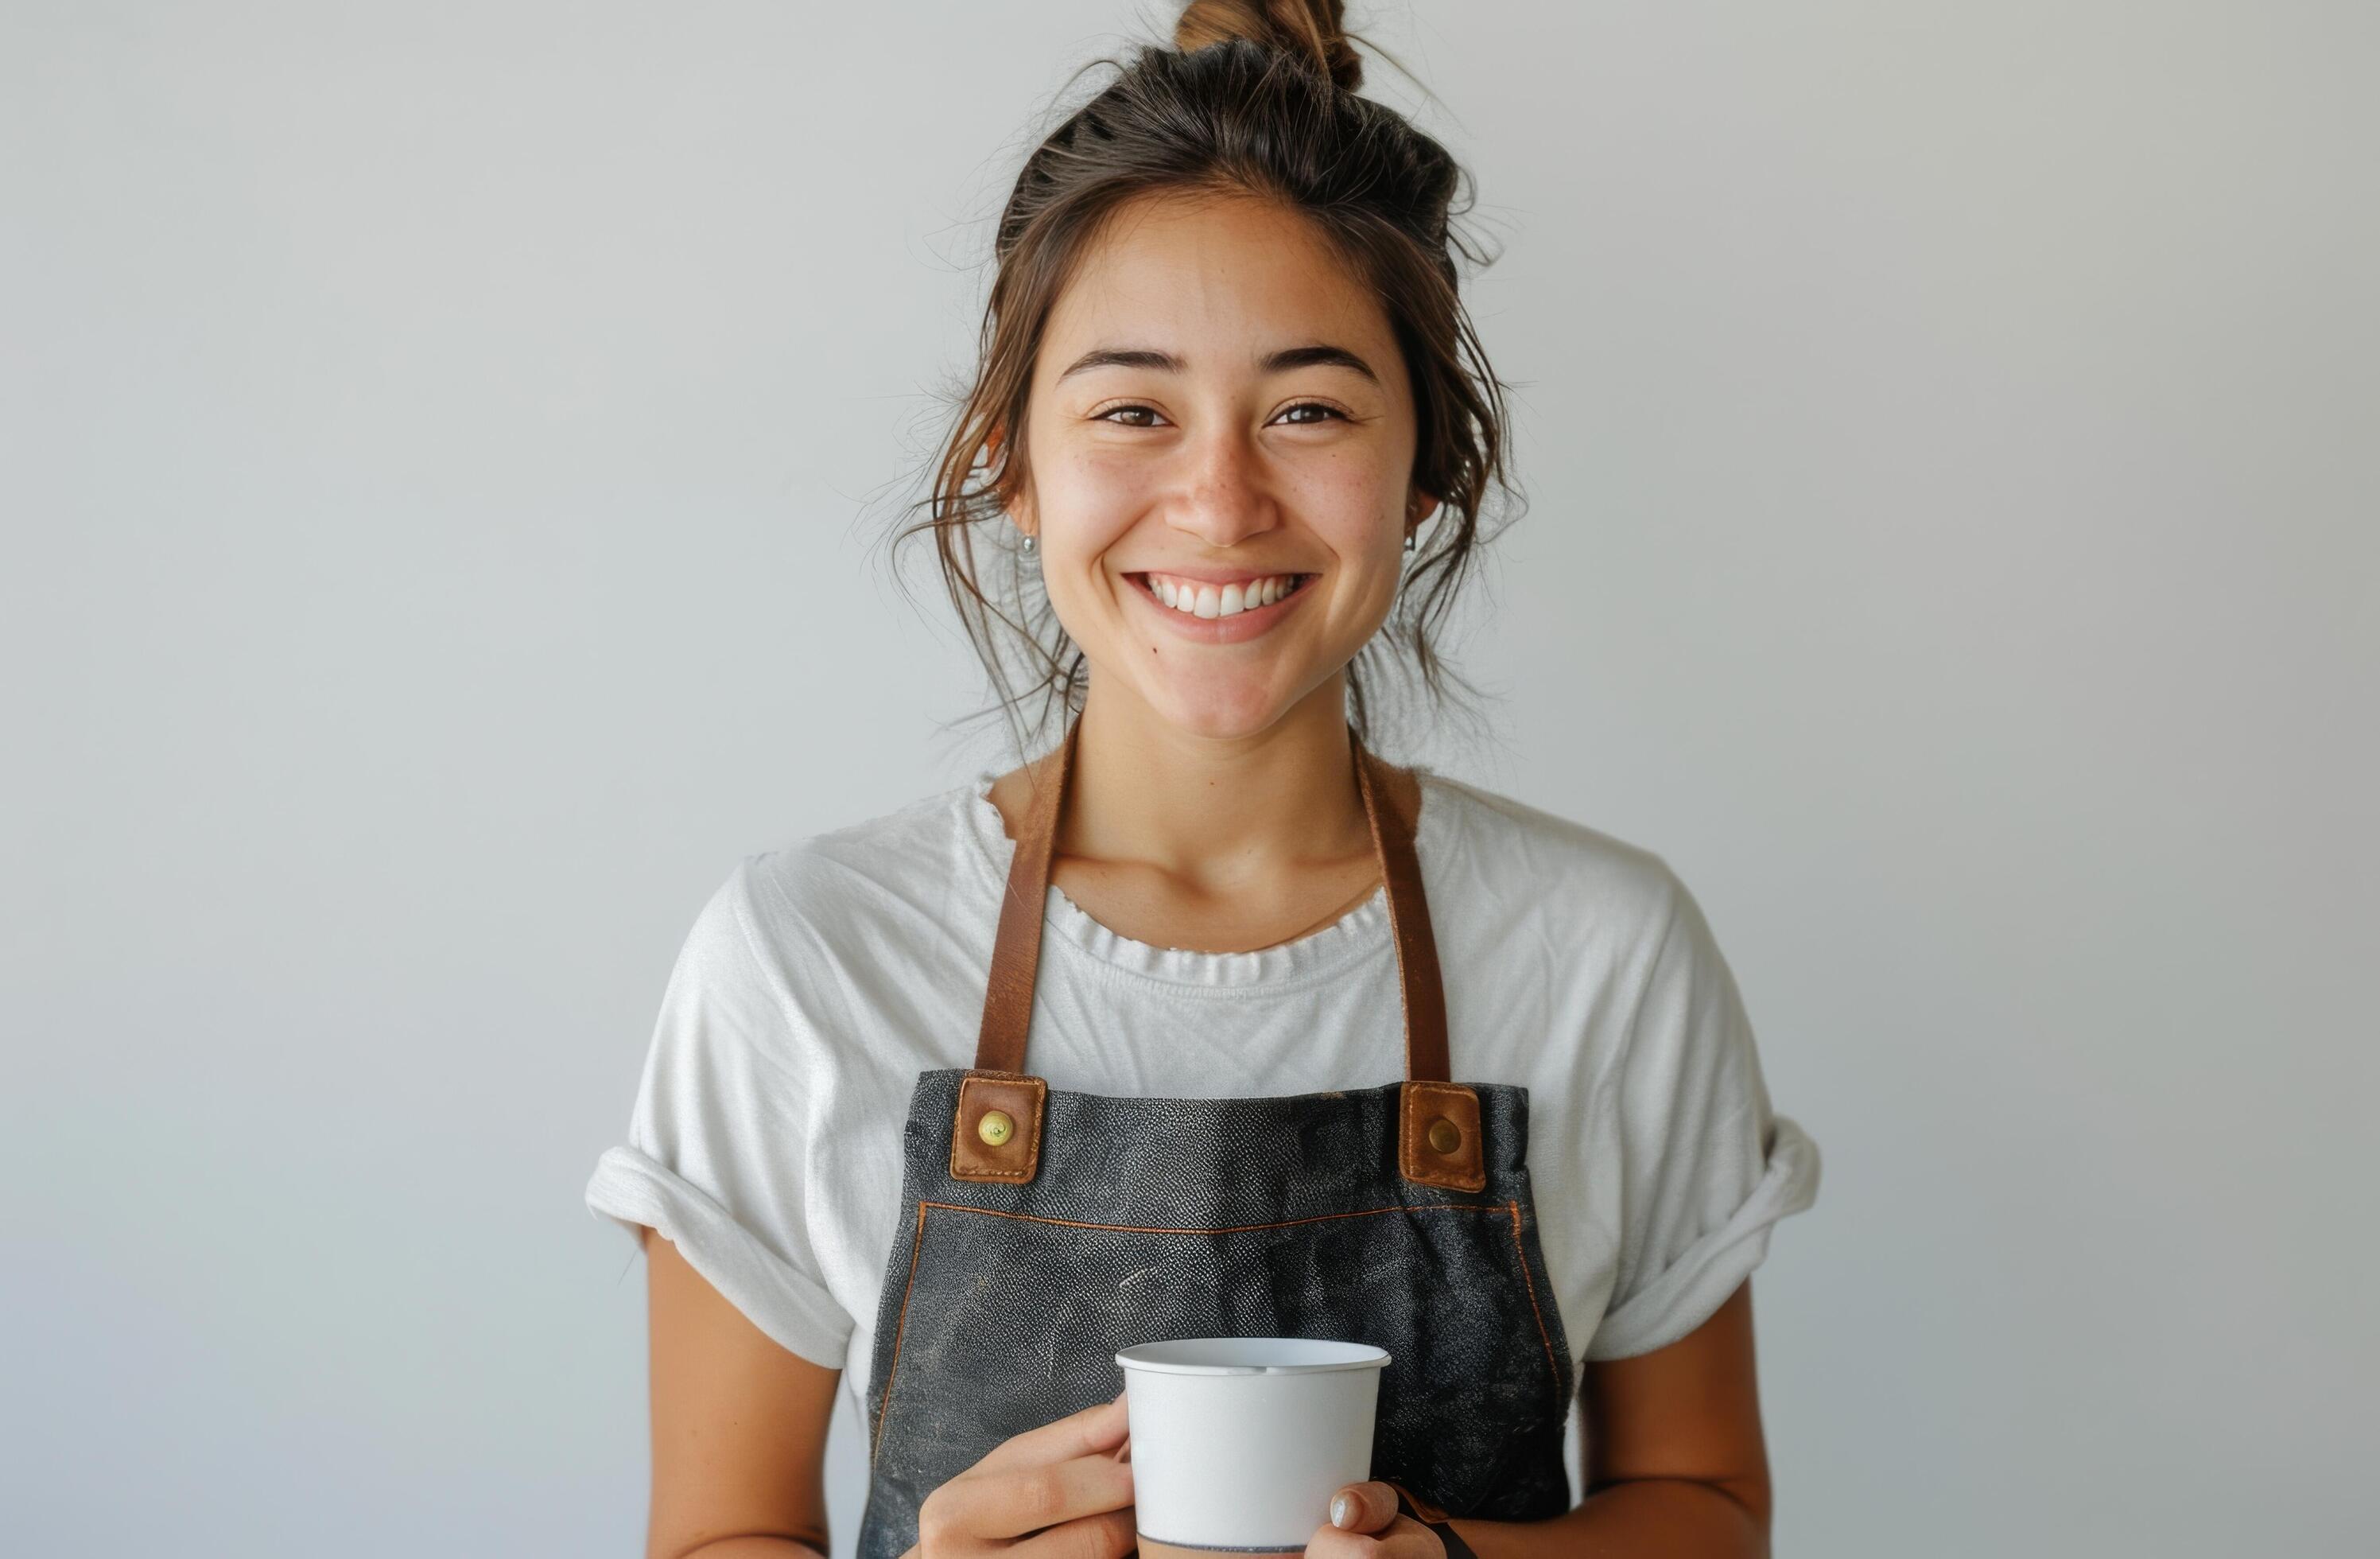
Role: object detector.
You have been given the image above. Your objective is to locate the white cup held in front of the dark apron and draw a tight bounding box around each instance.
[1116,1338,1388,1559]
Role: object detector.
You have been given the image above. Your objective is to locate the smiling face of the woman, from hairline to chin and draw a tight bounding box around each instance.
[1011,197,1438,736]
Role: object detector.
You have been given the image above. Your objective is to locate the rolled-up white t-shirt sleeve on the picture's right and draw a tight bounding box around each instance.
[1585,876,1819,1362]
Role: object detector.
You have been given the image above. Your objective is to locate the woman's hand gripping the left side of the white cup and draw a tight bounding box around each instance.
[902,1393,1138,1559]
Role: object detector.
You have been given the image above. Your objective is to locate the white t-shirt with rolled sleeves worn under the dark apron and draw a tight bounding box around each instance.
[585,767,1819,1423]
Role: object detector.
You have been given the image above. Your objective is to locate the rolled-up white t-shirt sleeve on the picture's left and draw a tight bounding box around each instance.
[585,861,854,1369]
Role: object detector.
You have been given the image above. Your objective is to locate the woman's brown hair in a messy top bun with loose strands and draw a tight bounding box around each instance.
[892,0,1512,752]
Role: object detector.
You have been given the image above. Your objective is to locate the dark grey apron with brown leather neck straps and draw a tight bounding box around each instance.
[859,714,1575,1559]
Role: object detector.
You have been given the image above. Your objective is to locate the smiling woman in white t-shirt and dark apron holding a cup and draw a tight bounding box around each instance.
[588,0,1819,1559]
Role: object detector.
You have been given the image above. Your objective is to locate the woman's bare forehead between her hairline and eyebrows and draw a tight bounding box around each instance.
[1040,192,1392,374]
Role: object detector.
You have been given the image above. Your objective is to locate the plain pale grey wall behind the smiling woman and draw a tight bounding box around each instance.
[0,0,2380,1559]
